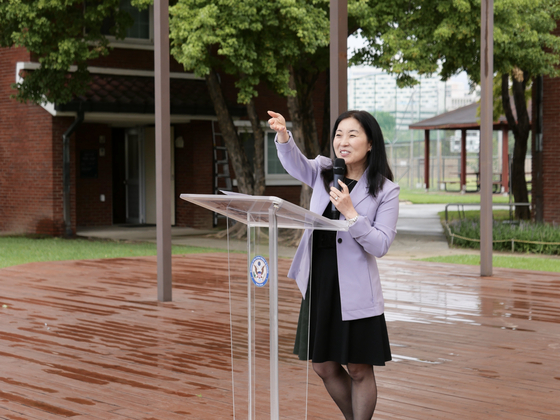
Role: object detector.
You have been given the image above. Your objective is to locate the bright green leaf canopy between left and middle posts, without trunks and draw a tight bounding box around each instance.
[166,0,329,103]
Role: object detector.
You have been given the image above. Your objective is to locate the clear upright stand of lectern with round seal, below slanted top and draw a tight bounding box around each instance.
[225,221,309,420]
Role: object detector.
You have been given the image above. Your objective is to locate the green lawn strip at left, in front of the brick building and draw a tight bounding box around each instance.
[0,236,224,268]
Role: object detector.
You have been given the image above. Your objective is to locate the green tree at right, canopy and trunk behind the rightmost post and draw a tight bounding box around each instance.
[352,0,560,219]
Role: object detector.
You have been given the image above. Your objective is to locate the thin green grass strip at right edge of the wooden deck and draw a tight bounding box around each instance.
[419,255,560,273]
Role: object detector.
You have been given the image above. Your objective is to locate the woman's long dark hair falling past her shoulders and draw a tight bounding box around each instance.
[321,111,393,197]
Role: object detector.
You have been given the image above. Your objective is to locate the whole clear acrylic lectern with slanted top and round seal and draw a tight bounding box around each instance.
[181,194,348,420]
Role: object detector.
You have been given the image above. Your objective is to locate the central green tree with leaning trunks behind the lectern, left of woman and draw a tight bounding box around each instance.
[166,0,329,207]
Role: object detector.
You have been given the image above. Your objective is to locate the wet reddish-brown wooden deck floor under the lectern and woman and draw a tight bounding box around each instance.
[0,254,560,420]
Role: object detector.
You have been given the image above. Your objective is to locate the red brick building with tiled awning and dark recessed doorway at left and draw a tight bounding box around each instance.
[0,23,324,235]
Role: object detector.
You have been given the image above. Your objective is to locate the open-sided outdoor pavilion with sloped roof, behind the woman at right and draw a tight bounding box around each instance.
[408,102,515,192]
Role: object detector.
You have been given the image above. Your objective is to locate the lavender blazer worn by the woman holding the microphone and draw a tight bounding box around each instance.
[276,133,399,321]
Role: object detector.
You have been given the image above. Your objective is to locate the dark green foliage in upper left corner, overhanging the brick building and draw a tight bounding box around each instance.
[0,0,133,104]
